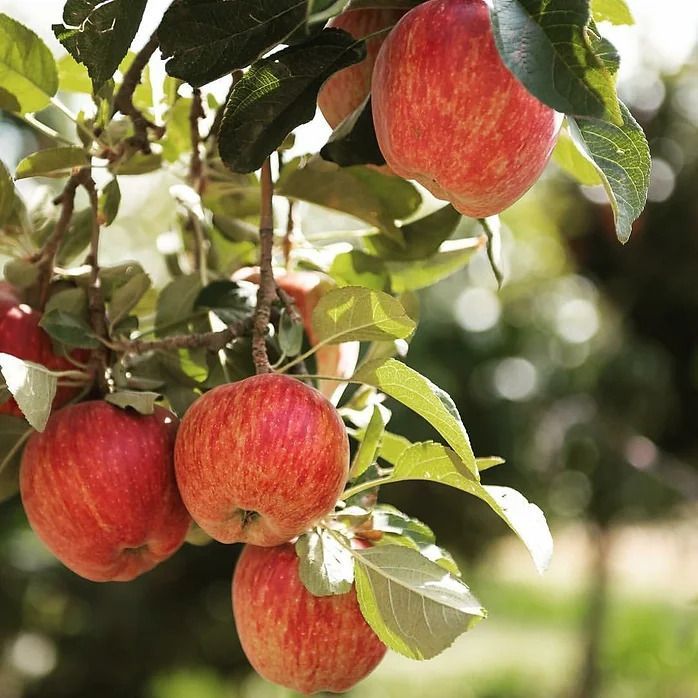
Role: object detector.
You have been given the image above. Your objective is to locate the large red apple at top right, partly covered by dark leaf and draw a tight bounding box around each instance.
[372,0,562,218]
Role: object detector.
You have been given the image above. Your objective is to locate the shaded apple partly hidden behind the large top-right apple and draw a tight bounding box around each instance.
[318,9,405,129]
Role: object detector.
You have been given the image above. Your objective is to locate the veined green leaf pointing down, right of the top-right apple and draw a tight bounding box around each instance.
[568,103,652,242]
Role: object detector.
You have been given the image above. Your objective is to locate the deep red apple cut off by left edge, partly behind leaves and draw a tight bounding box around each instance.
[0,282,89,417]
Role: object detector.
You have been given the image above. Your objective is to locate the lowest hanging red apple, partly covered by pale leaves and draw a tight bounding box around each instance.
[232,543,386,694]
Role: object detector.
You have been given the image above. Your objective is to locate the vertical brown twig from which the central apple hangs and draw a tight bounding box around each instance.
[252,158,276,373]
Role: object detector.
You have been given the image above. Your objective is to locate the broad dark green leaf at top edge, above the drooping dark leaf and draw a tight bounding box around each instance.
[158,0,306,87]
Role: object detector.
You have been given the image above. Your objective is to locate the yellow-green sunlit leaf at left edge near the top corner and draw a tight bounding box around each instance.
[0,14,58,113]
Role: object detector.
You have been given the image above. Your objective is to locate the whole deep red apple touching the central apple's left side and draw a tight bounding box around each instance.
[20,400,191,582]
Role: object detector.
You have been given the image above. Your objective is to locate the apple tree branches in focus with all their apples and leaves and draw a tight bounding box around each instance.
[0,0,650,692]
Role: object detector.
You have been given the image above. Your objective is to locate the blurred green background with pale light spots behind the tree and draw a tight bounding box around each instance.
[0,0,698,698]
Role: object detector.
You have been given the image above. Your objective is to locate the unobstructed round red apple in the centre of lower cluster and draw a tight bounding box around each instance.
[175,373,349,546]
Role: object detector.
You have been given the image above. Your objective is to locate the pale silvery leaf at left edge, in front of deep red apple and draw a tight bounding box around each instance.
[0,352,58,431]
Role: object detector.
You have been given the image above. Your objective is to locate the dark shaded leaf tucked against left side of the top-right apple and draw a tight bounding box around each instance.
[320,95,385,167]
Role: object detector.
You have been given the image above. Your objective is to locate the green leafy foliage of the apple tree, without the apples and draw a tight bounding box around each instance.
[0,0,649,658]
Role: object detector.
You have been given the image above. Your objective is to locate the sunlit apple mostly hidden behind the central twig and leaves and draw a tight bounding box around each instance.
[233,267,359,404]
